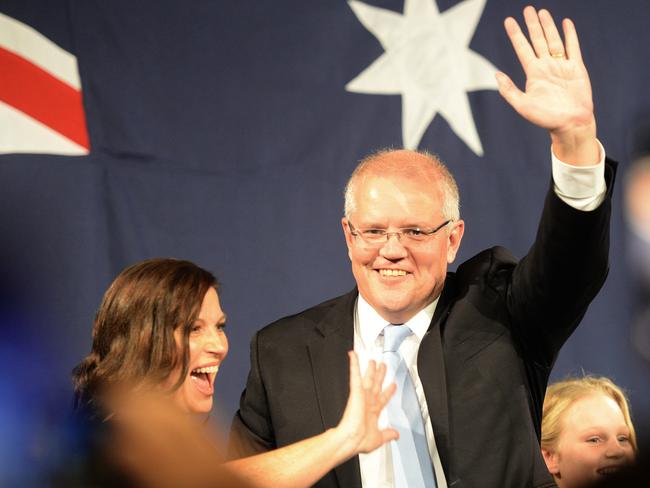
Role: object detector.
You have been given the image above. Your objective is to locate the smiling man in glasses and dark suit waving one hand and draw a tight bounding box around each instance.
[231,7,614,488]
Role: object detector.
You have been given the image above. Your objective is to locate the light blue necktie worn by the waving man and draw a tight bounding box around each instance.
[383,325,437,488]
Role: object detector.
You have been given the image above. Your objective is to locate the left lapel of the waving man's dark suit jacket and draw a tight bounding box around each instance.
[309,289,361,487]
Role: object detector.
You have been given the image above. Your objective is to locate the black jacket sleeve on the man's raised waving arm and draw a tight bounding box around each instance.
[506,160,616,368]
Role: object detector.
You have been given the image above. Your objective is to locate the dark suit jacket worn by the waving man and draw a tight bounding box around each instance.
[230,161,615,488]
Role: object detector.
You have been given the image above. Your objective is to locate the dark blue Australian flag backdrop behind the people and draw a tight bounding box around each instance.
[0,0,650,484]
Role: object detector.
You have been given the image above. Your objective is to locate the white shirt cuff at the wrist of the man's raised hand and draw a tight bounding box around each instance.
[551,141,607,211]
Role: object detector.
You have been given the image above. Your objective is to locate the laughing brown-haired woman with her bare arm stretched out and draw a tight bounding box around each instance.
[73,259,397,487]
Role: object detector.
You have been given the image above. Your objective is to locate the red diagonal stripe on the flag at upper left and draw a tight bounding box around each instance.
[0,47,90,149]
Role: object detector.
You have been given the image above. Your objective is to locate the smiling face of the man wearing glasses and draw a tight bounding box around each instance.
[342,153,464,323]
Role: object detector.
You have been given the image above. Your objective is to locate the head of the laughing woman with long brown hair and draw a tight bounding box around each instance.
[73,259,223,413]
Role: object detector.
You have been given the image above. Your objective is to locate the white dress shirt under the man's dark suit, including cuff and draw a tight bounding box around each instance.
[354,142,607,488]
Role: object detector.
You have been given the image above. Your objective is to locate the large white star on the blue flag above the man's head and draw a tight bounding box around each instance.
[345,0,497,156]
